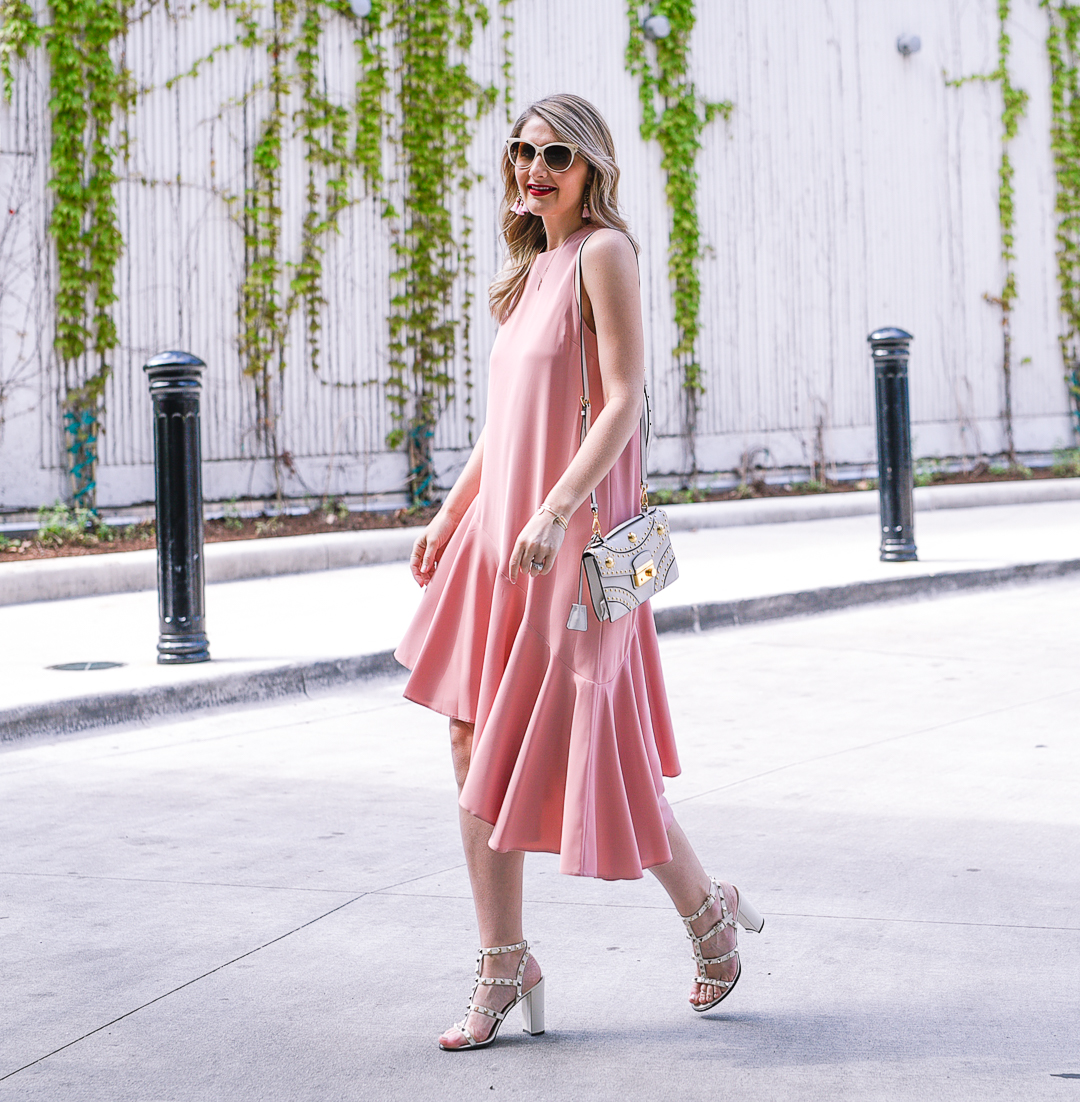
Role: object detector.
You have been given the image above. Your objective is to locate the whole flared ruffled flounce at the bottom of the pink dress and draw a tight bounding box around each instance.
[397,506,680,879]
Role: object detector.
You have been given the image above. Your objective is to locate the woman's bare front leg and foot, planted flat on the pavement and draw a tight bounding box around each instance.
[439,720,540,1048]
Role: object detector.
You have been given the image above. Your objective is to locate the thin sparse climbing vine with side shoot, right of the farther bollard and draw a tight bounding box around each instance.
[946,0,1028,468]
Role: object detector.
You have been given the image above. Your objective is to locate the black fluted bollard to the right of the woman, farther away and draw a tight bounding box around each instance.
[866,328,918,562]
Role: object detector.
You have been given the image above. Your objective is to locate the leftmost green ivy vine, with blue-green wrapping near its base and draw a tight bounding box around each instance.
[0,0,133,507]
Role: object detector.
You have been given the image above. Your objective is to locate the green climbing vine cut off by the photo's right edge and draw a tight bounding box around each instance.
[1041,0,1080,433]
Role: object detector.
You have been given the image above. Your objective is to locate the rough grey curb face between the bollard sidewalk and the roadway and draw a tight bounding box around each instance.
[0,559,1080,745]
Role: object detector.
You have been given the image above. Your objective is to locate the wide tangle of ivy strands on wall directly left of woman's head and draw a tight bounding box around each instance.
[178,0,498,506]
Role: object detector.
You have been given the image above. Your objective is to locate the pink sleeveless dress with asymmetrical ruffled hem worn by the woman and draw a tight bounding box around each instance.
[396,227,680,879]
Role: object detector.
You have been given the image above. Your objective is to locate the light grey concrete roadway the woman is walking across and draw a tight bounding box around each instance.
[0,581,1080,1102]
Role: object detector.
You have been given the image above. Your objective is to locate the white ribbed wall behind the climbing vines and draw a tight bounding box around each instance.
[0,0,1073,508]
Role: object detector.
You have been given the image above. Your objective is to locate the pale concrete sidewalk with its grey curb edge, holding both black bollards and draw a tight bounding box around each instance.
[0,495,1080,741]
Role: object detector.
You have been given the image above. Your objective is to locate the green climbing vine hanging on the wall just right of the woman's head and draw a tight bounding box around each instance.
[626,0,734,474]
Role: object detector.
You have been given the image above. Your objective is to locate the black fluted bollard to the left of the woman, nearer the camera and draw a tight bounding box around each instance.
[143,352,210,663]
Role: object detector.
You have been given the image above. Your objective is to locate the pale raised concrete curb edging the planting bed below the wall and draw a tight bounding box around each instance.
[0,478,1080,605]
